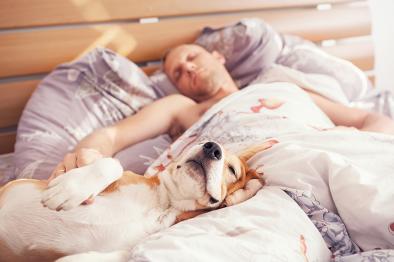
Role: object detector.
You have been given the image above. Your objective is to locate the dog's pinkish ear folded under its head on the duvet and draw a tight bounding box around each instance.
[223,169,265,206]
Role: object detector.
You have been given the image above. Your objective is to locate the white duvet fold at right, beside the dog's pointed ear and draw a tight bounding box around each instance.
[250,131,394,250]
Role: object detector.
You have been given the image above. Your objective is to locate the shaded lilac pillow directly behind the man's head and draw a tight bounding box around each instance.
[195,18,283,88]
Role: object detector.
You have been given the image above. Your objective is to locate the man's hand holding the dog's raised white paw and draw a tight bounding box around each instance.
[48,148,104,204]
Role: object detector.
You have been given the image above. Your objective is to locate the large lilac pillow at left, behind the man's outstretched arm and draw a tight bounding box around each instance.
[14,48,170,179]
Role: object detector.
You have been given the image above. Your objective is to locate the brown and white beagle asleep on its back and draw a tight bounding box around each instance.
[0,140,275,262]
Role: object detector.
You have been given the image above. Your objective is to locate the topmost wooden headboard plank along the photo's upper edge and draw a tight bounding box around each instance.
[0,0,358,28]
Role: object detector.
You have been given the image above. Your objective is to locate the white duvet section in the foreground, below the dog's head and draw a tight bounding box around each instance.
[130,187,331,262]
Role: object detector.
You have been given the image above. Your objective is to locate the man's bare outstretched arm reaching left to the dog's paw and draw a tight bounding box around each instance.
[51,95,195,179]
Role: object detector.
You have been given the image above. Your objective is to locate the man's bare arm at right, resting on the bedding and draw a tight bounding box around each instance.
[309,93,394,134]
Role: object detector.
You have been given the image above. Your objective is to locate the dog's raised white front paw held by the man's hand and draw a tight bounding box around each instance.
[41,158,123,210]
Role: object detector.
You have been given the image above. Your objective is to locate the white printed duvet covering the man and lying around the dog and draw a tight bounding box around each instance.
[130,83,394,261]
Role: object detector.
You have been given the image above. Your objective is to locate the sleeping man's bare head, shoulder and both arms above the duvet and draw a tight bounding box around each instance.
[51,45,394,178]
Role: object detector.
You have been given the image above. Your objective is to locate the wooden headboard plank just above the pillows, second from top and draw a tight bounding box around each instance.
[0,6,370,77]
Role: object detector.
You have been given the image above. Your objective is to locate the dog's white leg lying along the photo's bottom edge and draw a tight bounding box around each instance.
[56,250,129,262]
